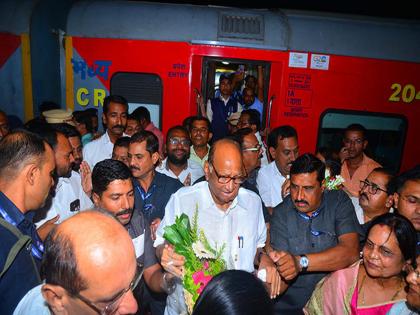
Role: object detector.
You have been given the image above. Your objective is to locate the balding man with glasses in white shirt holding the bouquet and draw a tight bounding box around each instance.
[154,139,278,315]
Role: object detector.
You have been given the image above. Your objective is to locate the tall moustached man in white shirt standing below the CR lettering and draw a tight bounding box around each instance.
[83,95,128,169]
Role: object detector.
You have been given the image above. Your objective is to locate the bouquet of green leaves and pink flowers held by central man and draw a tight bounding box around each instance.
[163,209,226,314]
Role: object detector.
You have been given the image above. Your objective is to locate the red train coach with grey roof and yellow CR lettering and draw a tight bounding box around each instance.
[1,1,420,171]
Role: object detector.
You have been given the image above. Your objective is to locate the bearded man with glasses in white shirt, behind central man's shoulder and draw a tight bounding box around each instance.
[156,126,204,186]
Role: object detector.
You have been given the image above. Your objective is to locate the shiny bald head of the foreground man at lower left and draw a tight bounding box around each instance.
[43,211,136,294]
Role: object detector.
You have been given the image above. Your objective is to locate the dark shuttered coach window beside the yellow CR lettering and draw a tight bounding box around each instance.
[111,72,163,128]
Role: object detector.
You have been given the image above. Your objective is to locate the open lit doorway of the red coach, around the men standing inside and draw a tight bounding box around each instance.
[202,58,270,125]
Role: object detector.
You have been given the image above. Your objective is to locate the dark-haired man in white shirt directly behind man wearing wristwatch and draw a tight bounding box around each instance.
[257,125,299,213]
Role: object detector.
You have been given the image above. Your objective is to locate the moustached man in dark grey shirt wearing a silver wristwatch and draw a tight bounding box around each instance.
[270,154,360,314]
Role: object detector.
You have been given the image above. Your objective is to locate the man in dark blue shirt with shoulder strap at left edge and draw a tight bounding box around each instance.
[0,131,55,314]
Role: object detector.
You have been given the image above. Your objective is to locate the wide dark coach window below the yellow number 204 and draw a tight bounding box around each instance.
[317,110,407,172]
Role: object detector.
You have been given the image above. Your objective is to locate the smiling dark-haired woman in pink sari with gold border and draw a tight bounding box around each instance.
[304,213,417,315]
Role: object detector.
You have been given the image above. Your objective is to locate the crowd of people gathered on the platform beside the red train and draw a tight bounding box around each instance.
[0,81,420,315]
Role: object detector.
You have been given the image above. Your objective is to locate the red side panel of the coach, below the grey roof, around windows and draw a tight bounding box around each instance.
[67,37,420,173]
